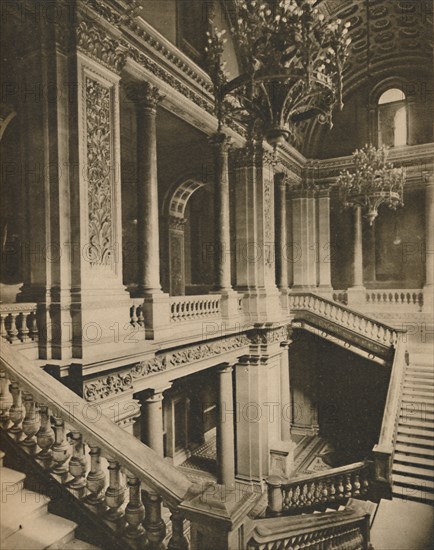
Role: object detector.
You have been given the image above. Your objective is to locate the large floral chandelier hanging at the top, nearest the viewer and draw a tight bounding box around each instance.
[206,0,351,148]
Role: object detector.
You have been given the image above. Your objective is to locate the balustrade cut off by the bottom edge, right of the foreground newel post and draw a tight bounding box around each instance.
[247,509,372,550]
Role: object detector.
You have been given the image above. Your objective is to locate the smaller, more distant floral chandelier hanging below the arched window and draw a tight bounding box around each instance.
[336,145,405,225]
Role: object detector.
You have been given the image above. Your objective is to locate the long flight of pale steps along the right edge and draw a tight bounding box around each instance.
[392,343,434,504]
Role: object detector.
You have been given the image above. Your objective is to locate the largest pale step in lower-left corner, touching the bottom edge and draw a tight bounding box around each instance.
[2,514,77,550]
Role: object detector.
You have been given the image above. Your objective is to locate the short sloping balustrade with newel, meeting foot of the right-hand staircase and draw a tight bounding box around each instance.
[267,461,371,515]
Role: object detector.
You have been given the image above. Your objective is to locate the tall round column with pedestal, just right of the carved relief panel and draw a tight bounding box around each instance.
[126,82,169,338]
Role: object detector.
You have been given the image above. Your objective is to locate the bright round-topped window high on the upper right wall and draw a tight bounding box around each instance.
[378,88,407,147]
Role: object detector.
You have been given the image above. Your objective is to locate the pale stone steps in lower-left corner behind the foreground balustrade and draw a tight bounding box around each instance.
[0,451,98,550]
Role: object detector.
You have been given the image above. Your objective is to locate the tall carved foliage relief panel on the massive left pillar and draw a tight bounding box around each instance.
[85,76,113,265]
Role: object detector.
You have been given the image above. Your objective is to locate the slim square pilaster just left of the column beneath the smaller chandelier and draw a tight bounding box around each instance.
[317,189,332,297]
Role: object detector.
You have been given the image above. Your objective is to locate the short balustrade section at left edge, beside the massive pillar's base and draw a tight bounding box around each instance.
[0,303,38,344]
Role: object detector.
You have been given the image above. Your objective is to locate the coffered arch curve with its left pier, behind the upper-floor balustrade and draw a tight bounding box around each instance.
[163,176,208,296]
